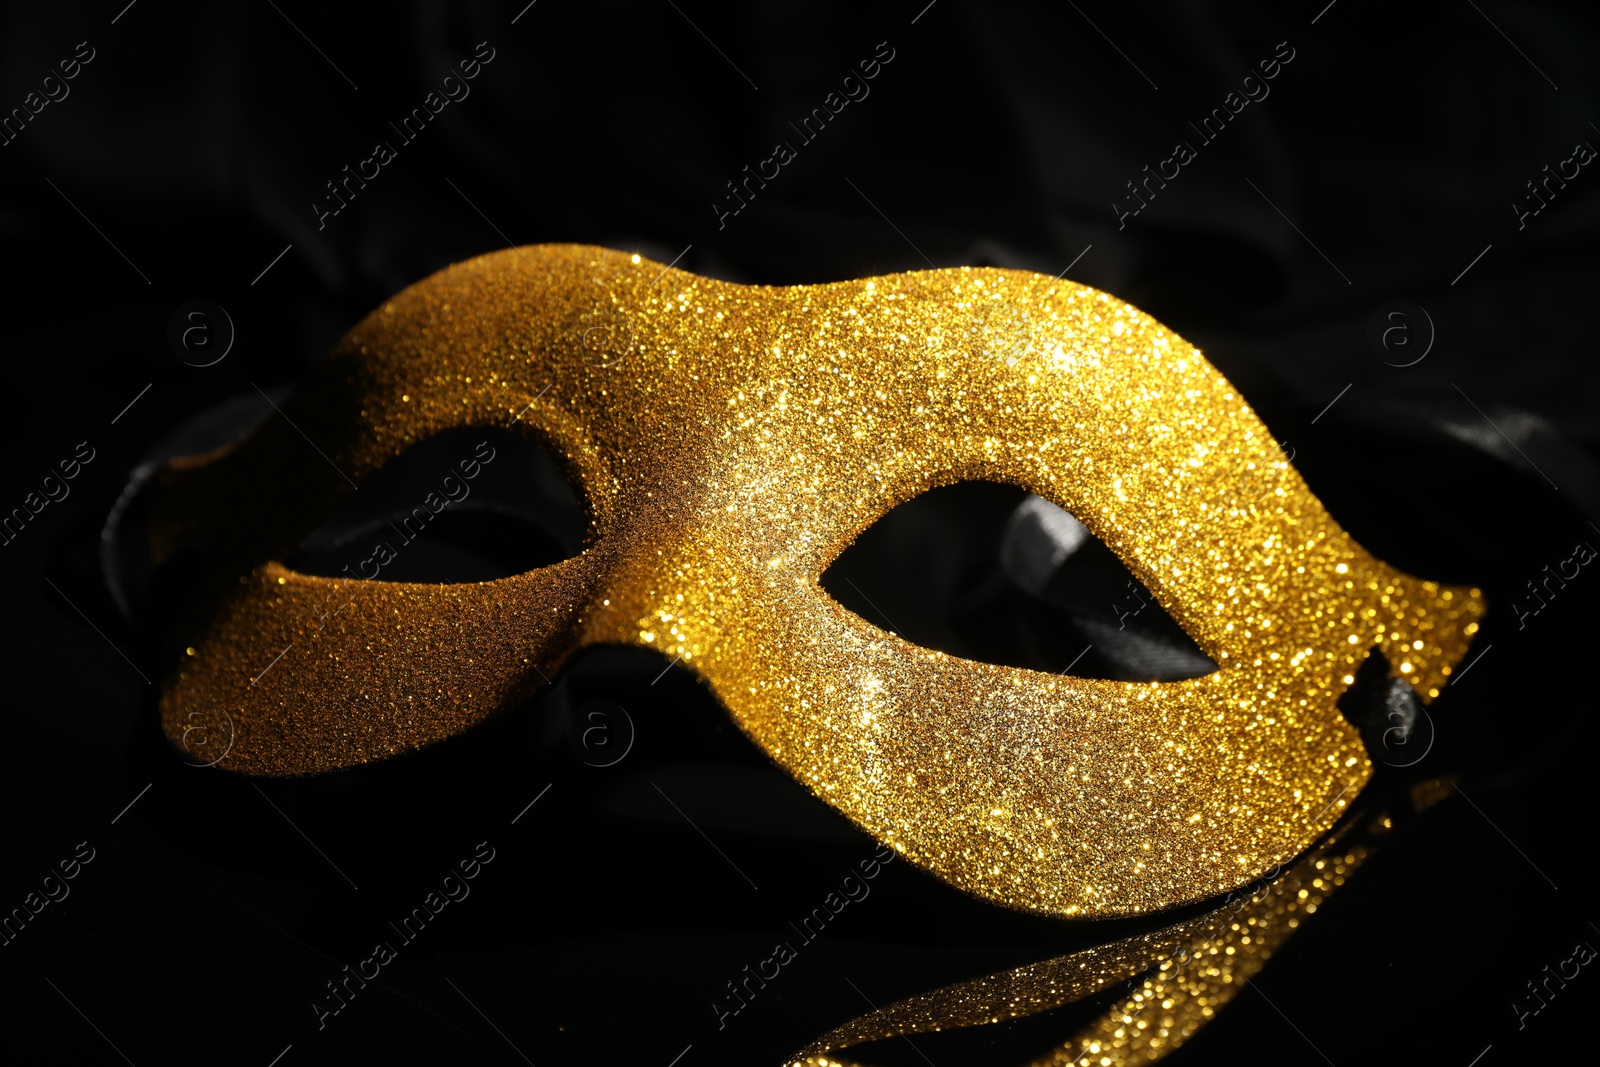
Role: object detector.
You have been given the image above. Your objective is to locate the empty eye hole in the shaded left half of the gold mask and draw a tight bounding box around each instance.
[285,427,589,584]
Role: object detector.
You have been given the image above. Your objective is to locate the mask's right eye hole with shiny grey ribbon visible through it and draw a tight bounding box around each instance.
[821,482,1218,681]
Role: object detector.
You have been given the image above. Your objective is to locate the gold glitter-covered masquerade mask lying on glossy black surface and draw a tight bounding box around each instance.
[150,246,1483,917]
